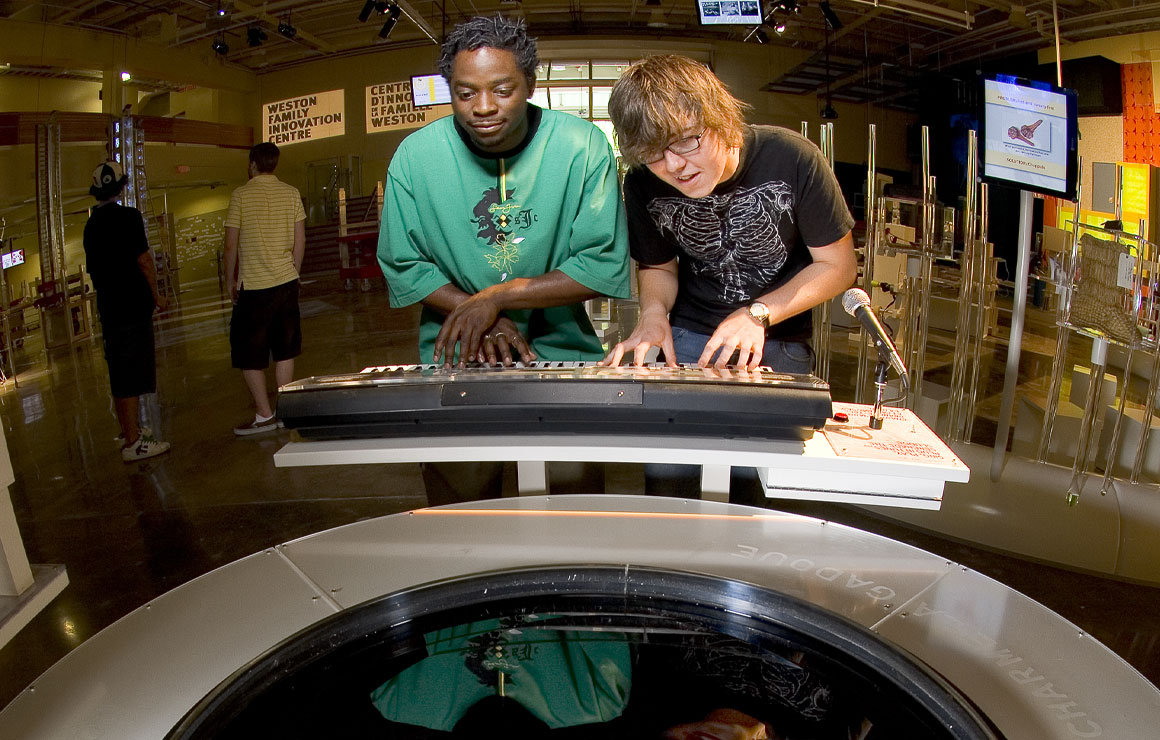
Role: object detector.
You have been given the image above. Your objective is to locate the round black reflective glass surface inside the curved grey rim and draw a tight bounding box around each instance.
[168,566,1000,740]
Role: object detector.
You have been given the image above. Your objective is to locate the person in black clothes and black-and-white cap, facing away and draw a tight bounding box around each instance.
[84,161,169,463]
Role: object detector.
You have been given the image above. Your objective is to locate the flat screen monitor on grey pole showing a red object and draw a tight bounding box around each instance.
[980,75,1079,201]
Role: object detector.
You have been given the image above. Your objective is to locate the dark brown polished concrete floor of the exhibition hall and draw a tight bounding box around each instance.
[0,273,1160,706]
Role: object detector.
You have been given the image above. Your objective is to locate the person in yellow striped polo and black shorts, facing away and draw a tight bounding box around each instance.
[225,142,306,436]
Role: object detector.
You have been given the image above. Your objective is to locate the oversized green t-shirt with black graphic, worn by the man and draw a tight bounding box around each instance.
[378,106,629,362]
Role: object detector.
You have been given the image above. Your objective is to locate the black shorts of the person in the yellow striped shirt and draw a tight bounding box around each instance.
[230,280,302,370]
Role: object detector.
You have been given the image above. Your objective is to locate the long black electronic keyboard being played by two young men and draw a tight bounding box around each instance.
[278,361,833,440]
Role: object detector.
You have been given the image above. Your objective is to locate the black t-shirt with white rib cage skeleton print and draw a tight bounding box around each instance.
[624,126,854,342]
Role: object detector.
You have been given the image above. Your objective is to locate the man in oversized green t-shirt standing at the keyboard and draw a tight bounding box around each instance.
[378,15,629,506]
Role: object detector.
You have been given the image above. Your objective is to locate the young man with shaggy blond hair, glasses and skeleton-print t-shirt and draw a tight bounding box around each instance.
[603,56,857,372]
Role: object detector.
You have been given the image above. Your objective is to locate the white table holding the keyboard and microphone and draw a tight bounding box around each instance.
[274,404,971,509]
